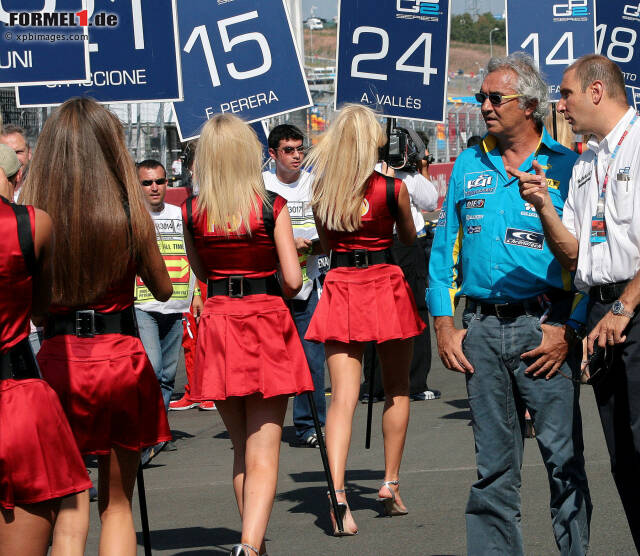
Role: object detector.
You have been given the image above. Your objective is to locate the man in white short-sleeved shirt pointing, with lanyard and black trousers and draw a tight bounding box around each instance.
[514,54,640,552]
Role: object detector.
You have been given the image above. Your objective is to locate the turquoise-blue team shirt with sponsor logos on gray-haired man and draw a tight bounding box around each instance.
[427,129,582,320]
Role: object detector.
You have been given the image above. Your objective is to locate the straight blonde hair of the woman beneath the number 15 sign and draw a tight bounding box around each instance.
[193,114,266,235]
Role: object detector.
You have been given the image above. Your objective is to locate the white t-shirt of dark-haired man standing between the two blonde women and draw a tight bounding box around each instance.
[262,172,329,299]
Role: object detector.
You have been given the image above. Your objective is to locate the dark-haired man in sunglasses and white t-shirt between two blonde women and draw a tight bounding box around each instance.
[263,124,329,448]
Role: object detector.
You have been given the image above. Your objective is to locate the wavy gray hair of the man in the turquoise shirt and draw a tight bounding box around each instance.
[487,52,549,126]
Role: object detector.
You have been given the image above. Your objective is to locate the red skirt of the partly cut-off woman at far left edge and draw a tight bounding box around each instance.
[0,379,91,510]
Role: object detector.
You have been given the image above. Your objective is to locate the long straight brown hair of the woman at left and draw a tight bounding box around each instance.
[23,98,156,307]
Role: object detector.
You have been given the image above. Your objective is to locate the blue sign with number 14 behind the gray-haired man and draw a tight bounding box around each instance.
[507,0,596,101]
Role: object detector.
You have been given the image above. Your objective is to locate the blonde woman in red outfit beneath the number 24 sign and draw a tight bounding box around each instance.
[306,105,425,535]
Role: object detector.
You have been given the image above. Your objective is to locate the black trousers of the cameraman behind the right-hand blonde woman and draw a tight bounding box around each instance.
[362,232,431,397]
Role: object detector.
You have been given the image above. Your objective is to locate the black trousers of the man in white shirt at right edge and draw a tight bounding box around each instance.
[588,300,640,553]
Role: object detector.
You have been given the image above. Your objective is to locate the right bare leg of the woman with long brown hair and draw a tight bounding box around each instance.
[98,447,140,556]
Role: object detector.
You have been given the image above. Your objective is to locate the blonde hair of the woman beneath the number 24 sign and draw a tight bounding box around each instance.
[305,104,387,232]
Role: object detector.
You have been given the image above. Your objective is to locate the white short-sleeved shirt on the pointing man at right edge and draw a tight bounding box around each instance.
[562,108,640,291]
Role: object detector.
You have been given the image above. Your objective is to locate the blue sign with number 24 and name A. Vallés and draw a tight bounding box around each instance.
[336,0,450,122]
